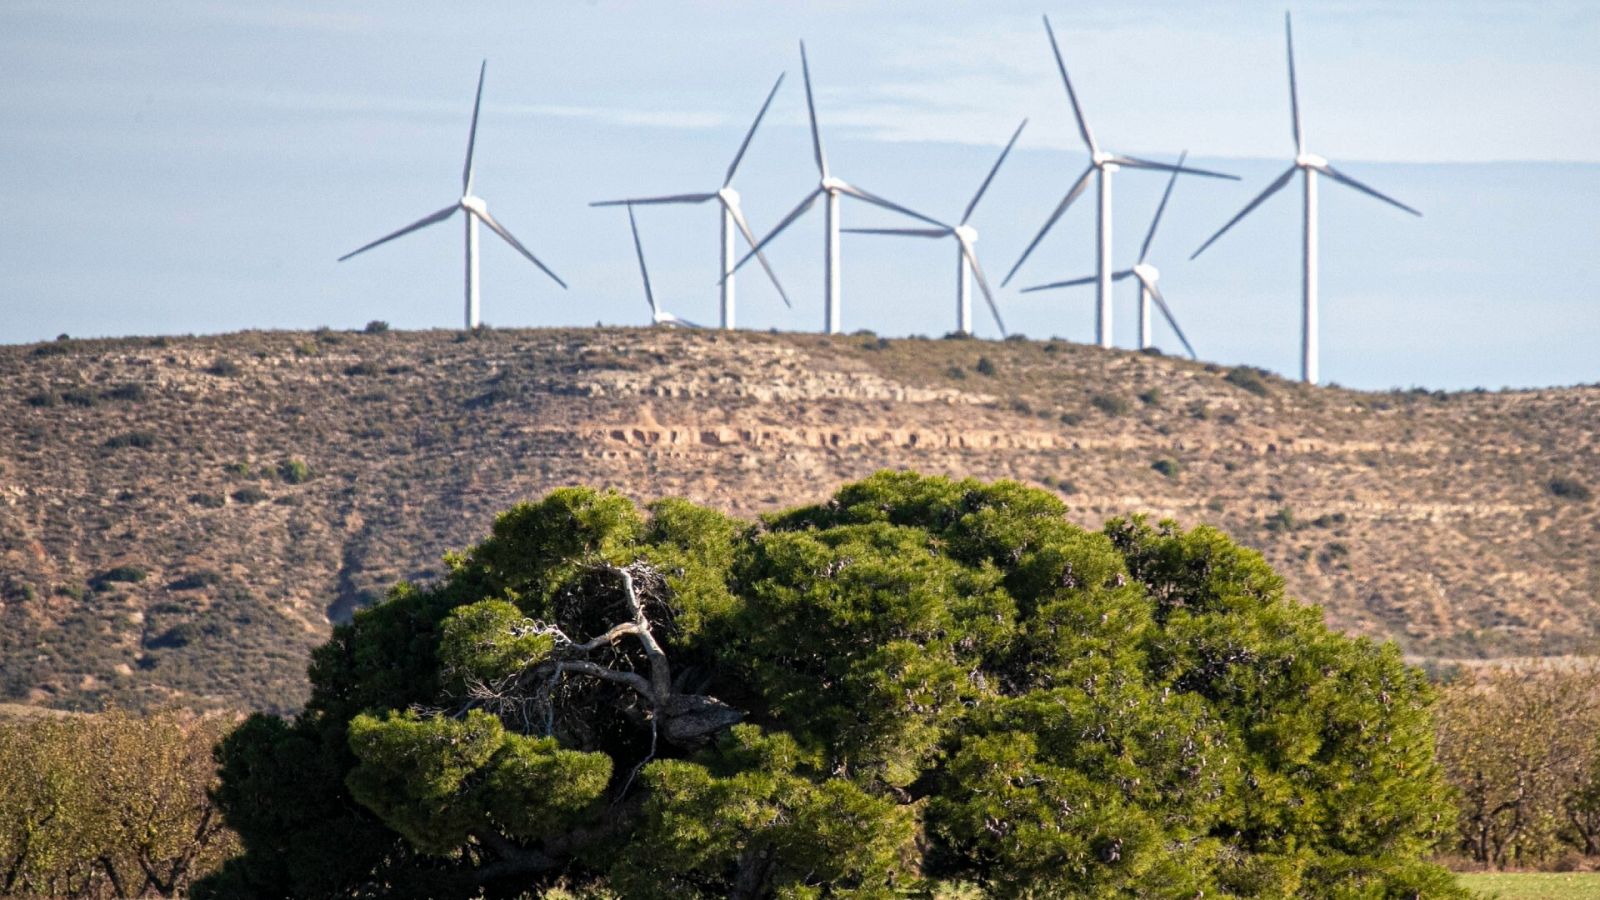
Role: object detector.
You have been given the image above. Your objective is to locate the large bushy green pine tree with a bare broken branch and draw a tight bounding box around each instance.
[202,472,1458,898]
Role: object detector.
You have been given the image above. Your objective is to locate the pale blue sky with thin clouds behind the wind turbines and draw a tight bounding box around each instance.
[0,0,1600,388]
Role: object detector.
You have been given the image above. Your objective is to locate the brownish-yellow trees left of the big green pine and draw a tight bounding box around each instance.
[0,711,238,898]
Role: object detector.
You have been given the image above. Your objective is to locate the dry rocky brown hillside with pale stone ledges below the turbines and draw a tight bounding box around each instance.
[0,328,1600,711]
